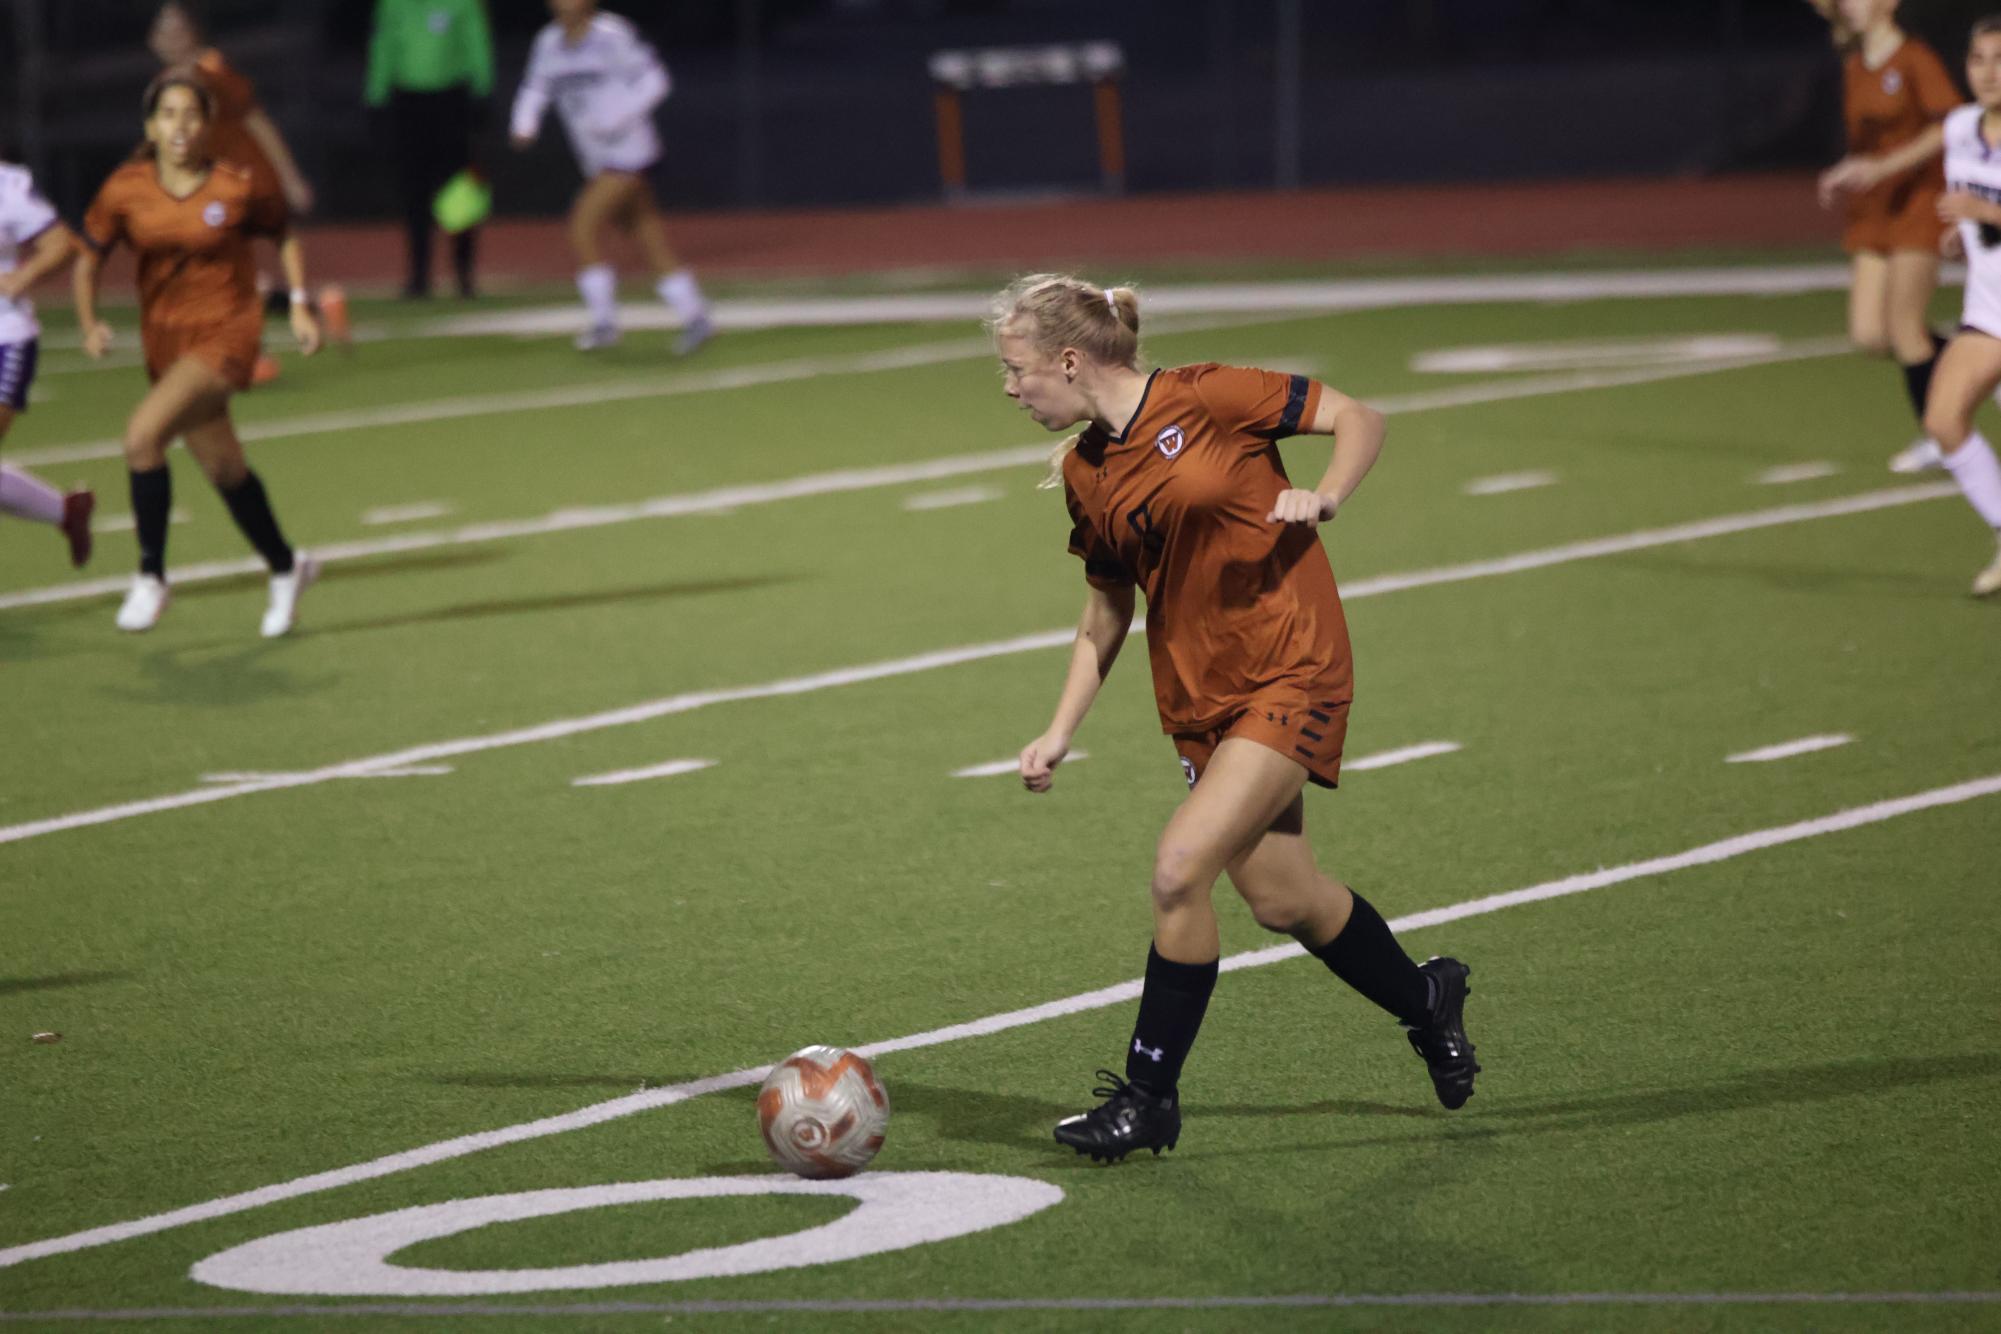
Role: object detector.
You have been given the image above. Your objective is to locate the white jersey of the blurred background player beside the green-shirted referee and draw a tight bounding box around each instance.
[512,14,672,176]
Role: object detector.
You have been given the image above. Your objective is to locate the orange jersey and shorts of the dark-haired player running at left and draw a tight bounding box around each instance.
[84,158,286,386]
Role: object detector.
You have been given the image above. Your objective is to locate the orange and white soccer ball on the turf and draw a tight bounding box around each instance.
[756,1046,888,1178]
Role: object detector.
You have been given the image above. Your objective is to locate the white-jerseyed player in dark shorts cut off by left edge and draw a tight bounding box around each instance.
[0,162,98,566]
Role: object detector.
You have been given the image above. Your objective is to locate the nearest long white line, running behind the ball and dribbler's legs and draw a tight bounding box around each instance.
[0,774,2001,1268]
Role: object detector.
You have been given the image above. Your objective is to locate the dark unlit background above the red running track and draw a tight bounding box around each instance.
[0,0,2001,218]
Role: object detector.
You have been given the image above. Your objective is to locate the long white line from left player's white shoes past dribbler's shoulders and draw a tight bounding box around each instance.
[0,344,1872,612]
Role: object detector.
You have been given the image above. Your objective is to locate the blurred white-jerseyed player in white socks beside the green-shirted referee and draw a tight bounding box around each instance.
[512,0,714,356]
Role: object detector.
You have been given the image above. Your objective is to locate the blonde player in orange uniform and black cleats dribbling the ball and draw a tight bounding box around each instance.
[990,274,1479,1160]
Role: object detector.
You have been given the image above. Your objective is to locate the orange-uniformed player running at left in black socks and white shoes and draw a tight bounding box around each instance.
[74,72,320,638]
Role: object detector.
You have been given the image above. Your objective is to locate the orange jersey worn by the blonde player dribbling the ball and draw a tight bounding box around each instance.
[1063,362,1353,734]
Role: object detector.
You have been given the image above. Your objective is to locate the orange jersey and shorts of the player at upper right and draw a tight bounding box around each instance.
[1841,38,1961,252]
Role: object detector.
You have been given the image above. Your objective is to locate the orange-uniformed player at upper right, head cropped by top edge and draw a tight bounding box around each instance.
[1809,0,1961,472]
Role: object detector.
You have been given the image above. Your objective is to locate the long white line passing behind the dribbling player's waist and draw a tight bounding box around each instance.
[0,482,1959,844]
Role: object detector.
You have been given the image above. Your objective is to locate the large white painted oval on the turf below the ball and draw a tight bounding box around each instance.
[188,1172,1063,1296]
